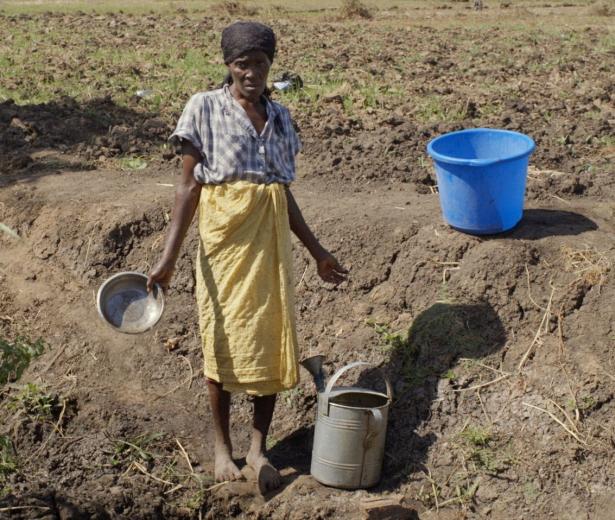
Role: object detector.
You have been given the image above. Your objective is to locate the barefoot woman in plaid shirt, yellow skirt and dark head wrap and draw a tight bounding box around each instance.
[148,22,346,492]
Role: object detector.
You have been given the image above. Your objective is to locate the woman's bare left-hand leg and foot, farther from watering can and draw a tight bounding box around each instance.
[207,379,242,482]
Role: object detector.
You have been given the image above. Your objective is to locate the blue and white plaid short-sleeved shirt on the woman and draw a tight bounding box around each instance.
[169,86,301,184]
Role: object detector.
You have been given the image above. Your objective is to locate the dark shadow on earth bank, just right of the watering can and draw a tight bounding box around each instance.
[358,302,506,491]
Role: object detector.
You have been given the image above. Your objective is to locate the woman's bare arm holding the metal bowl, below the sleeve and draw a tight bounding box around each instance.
[147,141,201,291]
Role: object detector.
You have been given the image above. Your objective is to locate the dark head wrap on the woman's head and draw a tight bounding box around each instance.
[221,22,275,65]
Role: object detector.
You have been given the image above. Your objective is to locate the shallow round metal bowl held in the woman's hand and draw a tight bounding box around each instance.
[96,272,164,334]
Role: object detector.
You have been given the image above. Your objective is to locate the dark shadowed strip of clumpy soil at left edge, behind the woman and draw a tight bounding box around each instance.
[0,97,171,183]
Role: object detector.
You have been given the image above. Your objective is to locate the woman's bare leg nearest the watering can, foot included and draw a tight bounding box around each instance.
[246,394,281,493]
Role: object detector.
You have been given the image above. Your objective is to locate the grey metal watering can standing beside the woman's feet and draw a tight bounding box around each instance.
[301,356,392,489]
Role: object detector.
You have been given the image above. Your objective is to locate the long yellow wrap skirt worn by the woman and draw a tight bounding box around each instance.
[196,181,299,395]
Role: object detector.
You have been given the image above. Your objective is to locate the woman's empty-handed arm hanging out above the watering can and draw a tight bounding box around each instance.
[286,186,348,284]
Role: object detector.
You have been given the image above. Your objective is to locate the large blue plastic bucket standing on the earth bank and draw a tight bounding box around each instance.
[427,128,536,235]
